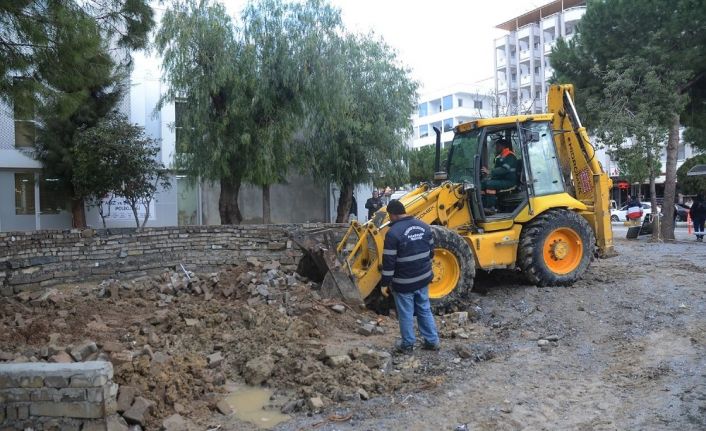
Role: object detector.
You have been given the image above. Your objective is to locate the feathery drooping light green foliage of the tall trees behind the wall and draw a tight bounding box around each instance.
[156,0,416,222]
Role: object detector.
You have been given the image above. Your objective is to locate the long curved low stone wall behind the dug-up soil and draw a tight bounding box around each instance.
[0,224,345,295]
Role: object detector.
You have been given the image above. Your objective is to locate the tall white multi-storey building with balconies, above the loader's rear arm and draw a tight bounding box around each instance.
[495,0,586,115]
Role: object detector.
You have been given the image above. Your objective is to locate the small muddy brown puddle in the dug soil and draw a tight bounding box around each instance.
[226,386,290,429]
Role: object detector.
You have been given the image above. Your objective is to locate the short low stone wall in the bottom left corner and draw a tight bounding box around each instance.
[0,361,119,430]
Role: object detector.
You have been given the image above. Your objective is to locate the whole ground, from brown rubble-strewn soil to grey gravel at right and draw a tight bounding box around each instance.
[0,239,706,431]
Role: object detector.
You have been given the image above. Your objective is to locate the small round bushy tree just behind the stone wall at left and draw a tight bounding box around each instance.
[71,112,170,227]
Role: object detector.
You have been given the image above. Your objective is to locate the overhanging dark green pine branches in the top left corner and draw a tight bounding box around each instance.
[0,0,154,101]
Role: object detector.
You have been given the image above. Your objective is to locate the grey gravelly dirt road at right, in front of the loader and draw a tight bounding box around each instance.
[277,239,706,431]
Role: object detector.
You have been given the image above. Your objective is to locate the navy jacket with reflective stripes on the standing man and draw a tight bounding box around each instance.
[382,216,434,293]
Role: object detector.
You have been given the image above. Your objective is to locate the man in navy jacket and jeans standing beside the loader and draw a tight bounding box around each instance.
[381,199,439,353]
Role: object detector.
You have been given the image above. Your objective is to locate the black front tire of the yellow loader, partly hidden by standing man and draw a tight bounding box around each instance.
[431,226,476,313]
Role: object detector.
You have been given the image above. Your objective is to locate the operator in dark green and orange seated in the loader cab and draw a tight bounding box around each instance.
[481,138,518,215]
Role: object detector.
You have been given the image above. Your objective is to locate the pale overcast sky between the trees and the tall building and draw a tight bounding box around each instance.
[223,0,550,93]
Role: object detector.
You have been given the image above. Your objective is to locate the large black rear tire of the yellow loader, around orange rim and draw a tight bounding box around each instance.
[517,209,596,286]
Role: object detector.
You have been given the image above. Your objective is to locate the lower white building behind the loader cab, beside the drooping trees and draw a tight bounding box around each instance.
[410,81,495,148]
